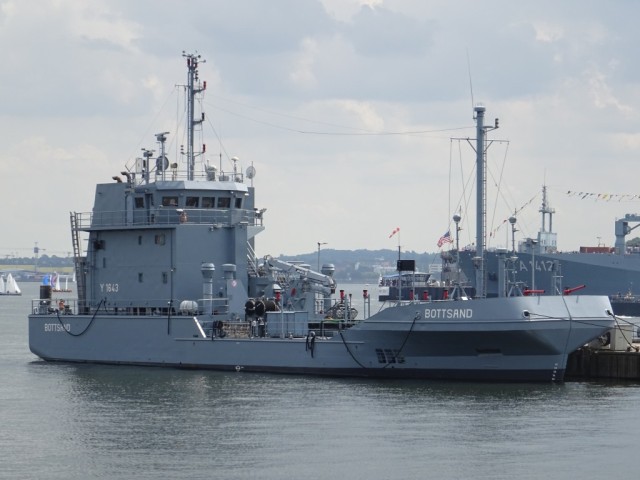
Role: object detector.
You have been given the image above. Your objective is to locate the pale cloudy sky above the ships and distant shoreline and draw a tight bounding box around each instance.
[0,0,640,258]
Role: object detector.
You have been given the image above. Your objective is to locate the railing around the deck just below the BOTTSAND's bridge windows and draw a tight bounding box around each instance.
[76,207,262,230]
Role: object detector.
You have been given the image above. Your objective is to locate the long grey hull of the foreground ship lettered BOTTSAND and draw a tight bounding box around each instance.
[29,296,613,382]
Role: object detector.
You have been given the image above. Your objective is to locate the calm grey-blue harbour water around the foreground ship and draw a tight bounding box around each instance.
[0,284,640,480]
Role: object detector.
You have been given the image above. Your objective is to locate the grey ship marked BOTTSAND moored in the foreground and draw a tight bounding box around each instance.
[29,54,614,382]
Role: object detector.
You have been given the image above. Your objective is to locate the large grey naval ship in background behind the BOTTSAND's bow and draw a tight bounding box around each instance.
[458,186,640,317]
